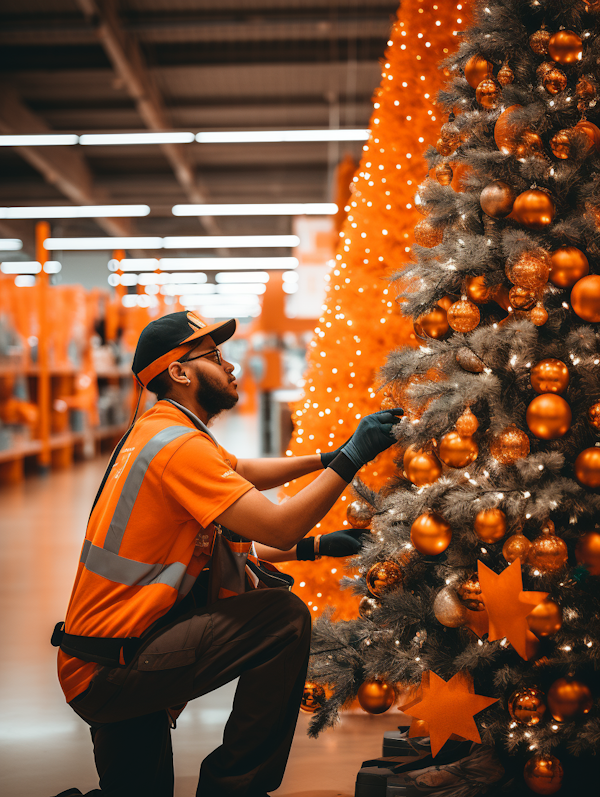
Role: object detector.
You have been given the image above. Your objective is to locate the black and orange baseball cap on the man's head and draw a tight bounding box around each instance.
[131,310,237,387]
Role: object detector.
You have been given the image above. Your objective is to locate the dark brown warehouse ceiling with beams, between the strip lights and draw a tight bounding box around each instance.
[0,0,398,255]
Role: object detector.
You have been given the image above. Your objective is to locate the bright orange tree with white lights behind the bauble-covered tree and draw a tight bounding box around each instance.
[284,0,474,618]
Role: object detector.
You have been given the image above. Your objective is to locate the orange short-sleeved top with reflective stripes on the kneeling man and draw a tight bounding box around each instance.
[58,401,253,701]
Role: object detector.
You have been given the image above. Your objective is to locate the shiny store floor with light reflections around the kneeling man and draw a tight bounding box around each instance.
[0,416,399,797]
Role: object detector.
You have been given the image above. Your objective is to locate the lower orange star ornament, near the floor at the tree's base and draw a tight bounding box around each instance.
[402,670,498,756]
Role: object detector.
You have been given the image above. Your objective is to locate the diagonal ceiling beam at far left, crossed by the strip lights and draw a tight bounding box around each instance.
[0,87,132,235]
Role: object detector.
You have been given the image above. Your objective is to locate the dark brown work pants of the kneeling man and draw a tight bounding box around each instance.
[71,589,310,797]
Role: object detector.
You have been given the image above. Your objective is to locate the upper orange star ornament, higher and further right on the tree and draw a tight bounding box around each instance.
[477,558,549,660]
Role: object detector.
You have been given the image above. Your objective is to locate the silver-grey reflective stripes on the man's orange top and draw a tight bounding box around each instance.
[79,426,194,590]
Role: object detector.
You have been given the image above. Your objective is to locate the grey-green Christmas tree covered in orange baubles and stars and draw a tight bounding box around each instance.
[309,0,600,795]
